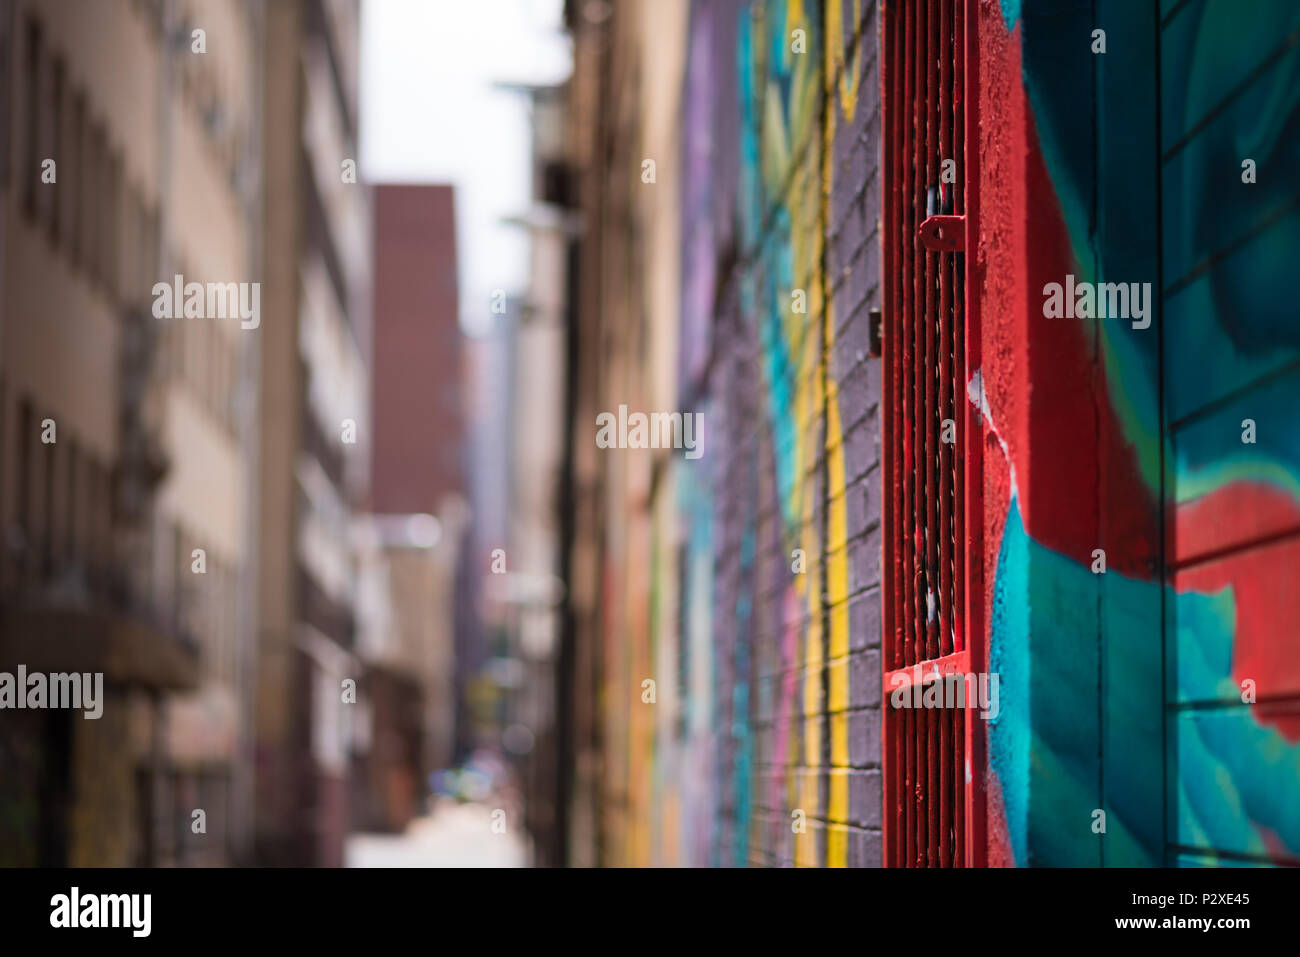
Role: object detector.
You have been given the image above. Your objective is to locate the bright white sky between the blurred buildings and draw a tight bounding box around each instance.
[360,0,569,334]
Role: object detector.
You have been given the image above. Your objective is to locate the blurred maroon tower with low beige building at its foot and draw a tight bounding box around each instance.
[352,185,469,831]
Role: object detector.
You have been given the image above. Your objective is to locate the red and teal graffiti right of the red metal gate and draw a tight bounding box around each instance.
[980,0,1300,865]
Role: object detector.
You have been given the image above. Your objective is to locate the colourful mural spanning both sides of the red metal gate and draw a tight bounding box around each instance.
[592,0,1300,866]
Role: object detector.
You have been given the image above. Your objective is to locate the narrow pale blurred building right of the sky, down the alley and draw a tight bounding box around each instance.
[488,87,577,865]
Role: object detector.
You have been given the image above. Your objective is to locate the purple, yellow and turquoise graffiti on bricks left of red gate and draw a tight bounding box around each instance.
[655,0,880,866]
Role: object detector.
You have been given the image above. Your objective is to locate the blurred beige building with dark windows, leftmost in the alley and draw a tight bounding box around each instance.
[0,0,261,866]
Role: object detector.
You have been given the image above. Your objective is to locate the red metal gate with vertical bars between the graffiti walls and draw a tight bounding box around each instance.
[880,0,985,867]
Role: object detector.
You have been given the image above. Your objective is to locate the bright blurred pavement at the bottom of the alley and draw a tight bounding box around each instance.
[343,798,525,867]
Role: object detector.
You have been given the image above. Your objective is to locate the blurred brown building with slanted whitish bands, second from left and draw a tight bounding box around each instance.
[254,0,373,865]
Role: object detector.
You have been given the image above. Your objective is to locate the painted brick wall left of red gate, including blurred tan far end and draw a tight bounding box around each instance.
[569,0,880,866]
